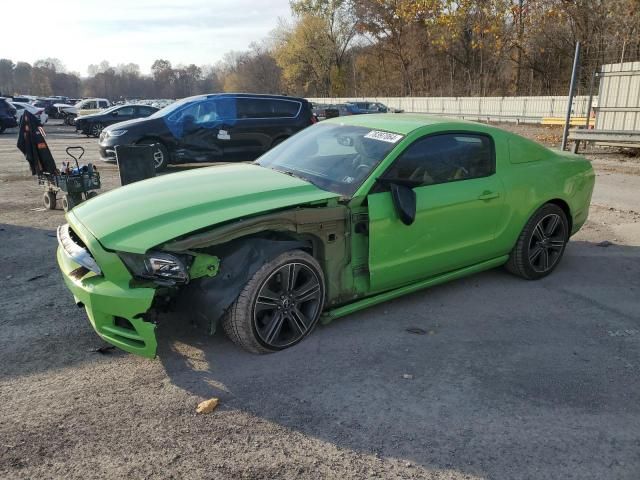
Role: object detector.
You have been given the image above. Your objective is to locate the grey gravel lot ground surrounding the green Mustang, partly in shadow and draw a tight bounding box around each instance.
[0,121,640,480]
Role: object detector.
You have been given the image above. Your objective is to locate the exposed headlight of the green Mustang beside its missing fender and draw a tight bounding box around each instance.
[118,252,190,285]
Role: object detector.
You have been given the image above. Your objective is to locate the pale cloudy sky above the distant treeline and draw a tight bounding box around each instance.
[0,0,291,76]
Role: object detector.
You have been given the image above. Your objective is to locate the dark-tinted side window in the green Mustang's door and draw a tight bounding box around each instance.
[385,133,495,186]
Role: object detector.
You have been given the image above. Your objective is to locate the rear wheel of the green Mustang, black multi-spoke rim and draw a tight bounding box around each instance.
[506,203,569,280]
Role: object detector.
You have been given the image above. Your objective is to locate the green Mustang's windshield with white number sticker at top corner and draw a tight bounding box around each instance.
[255,124,402,197]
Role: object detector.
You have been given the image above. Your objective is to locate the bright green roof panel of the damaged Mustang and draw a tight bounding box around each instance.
[322,113,486,135]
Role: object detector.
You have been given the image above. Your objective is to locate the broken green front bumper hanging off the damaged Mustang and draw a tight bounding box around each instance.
[57,216,157,358]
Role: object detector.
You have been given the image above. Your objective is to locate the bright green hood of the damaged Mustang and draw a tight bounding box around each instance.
[67,164,338,253]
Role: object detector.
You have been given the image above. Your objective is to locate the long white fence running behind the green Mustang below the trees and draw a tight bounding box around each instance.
[308,96,597,123]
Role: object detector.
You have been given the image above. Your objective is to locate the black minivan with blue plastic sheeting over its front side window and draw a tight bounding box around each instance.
[100,93,317,170]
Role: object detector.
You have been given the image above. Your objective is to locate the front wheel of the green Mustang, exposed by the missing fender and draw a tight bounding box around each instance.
[222,250,325,353]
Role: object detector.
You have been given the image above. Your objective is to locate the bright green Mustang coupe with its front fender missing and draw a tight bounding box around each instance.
[57,115,595,357]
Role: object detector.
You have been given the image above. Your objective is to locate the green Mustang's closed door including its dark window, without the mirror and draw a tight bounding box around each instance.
[367,132,505,291]
